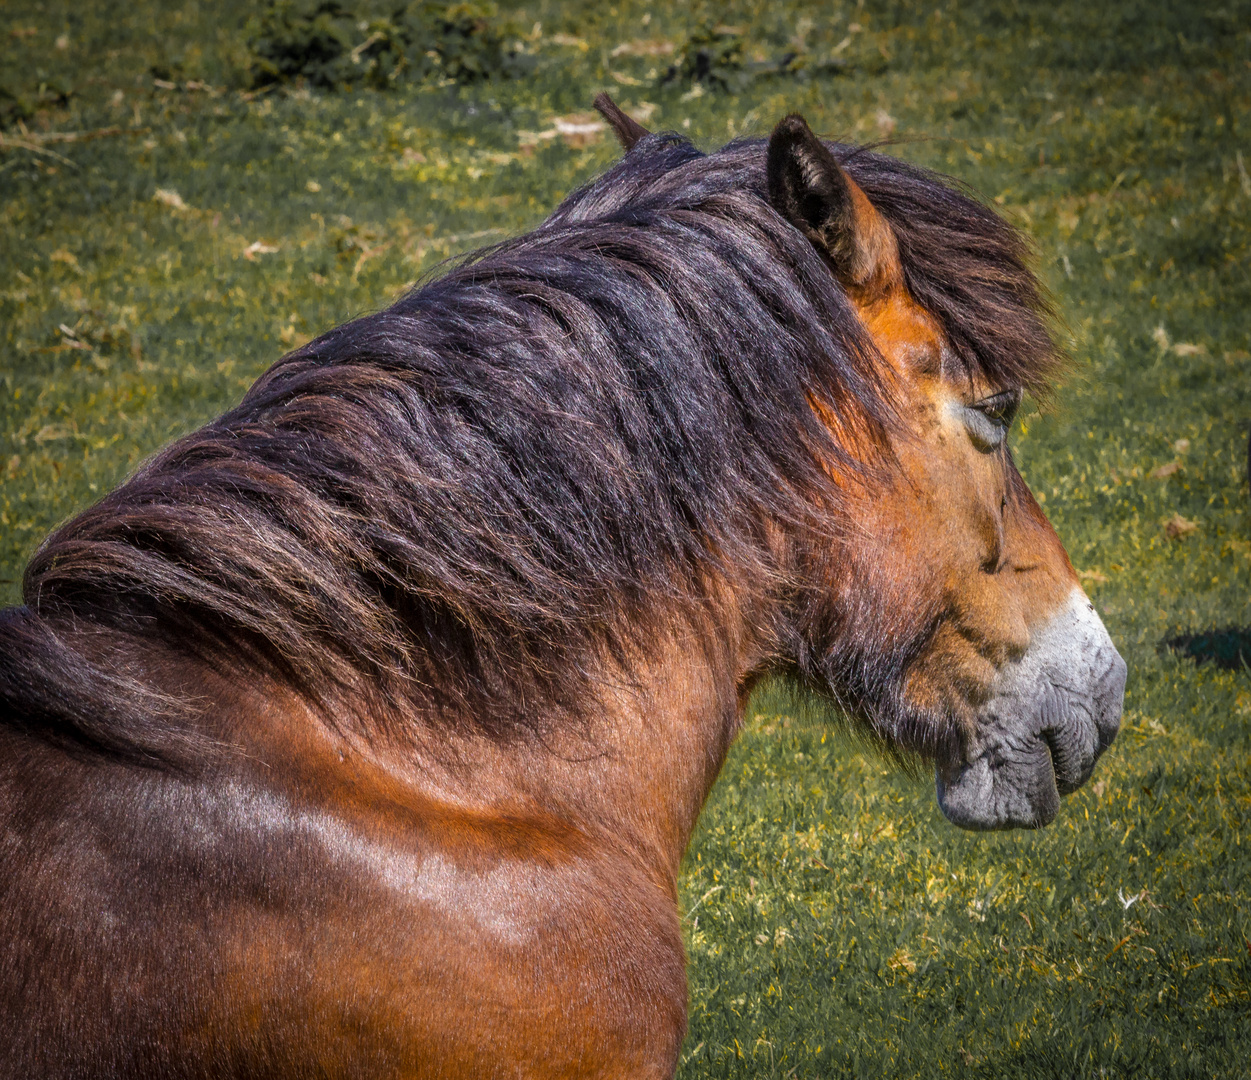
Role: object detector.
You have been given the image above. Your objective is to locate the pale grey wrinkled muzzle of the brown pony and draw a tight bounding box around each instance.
[937,587,1126,830]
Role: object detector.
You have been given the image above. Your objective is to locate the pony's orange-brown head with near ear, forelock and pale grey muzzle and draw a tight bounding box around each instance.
[767,115,1126,828]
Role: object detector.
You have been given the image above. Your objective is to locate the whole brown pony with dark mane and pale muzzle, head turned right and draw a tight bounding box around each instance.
[0,99,1125,1077]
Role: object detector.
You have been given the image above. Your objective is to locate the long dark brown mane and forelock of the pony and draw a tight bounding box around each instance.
[0,136,1055,757]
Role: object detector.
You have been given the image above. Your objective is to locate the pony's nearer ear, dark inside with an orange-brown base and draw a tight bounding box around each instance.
[766,114,902,288]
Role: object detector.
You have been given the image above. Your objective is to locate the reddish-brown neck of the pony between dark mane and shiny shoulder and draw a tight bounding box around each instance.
[225,620,763,895]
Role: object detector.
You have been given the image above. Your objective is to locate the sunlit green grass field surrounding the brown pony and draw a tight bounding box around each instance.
[0,0,1251,1077]
